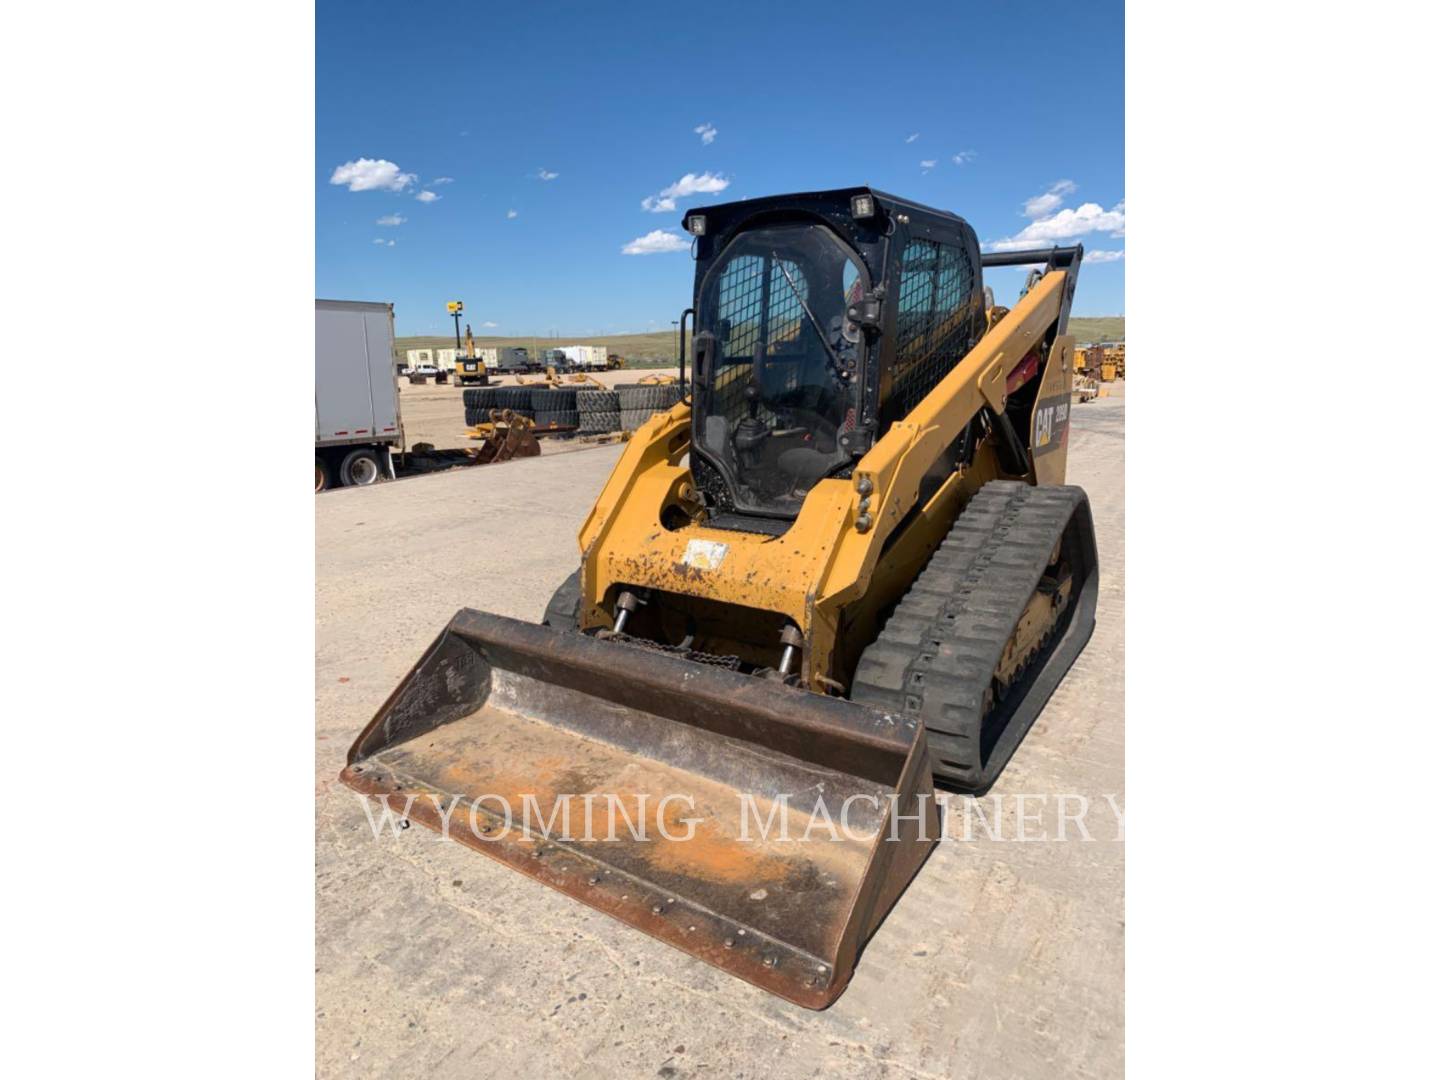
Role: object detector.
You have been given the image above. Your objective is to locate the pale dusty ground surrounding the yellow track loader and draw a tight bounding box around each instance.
[315,386,1125,1080]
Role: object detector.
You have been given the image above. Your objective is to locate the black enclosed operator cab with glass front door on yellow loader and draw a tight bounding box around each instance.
[685,187,985,531]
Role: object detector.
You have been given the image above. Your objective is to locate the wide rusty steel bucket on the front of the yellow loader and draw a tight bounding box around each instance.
[340,611,937,1008]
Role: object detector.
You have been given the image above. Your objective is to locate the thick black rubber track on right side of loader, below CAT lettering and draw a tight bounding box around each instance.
[850,481,1099,793]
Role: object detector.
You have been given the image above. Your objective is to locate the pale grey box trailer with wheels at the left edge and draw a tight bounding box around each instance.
[315,300,405,491]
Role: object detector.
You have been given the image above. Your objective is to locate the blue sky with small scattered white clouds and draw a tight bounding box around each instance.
[315,0,1125,336]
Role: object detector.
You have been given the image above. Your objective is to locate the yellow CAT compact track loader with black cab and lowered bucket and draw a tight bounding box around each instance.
[341,187,1097,1008]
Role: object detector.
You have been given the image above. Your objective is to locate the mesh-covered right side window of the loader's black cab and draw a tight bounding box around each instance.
[891,238,975,415]
